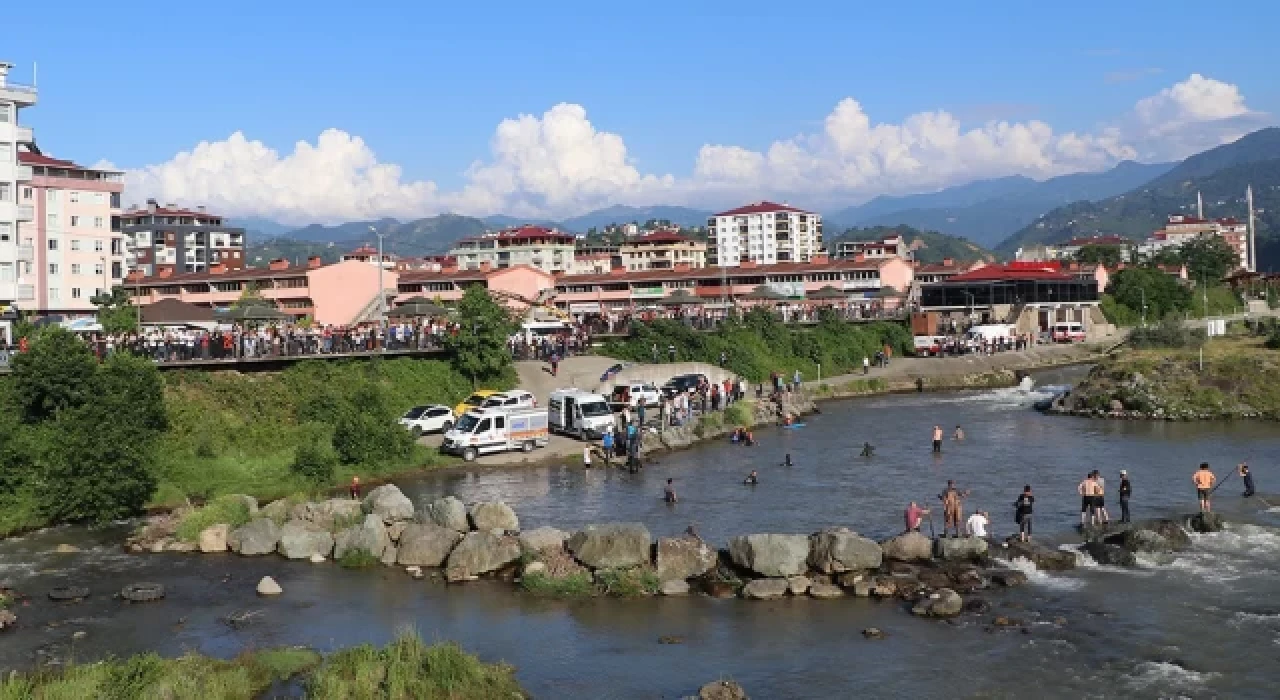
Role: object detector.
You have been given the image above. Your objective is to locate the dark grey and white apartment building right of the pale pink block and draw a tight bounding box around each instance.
[120,200,244,276]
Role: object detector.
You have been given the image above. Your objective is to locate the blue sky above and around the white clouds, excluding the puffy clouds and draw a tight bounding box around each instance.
[0,0,1280,220]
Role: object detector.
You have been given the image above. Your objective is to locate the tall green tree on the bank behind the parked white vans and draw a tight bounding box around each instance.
[445,285,516,384]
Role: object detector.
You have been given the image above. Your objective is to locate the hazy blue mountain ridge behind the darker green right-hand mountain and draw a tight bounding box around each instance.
[824,161,1172,246]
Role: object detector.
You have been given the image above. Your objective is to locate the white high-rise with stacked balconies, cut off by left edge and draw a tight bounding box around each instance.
[0,63,36,343]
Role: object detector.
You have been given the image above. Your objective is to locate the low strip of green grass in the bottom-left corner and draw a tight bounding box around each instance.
[0,649,320,700]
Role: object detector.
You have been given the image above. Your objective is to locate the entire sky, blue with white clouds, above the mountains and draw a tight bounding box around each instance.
[0,0,1280,224]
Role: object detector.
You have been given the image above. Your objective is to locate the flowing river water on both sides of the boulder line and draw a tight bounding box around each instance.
[0,370,1280,699]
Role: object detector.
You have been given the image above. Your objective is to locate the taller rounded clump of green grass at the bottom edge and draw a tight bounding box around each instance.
[307,632,527,700]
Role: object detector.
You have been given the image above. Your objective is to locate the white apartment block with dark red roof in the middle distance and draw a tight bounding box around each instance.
[707,202,823,267]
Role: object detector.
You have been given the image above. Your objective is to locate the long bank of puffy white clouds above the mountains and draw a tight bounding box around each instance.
[127,74,1270,223]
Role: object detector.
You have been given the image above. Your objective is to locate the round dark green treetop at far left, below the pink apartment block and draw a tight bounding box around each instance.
[12,326,100,424]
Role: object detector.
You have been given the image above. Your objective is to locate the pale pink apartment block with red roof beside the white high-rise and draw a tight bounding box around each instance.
[18,152,125,316]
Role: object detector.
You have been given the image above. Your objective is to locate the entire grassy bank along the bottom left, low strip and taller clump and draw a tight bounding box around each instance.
[0,633,526,700]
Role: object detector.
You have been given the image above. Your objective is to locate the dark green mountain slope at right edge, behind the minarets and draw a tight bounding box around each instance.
[996,128,1280,263]
